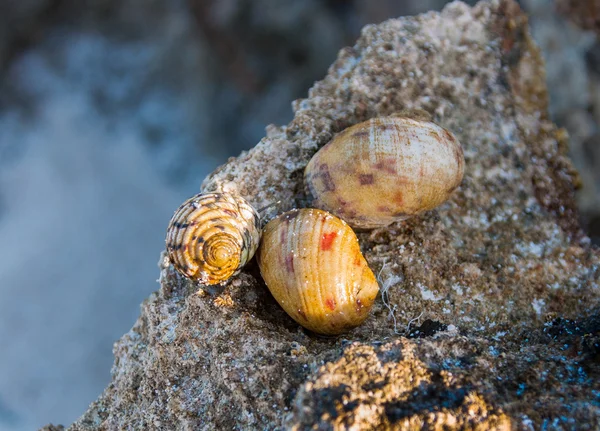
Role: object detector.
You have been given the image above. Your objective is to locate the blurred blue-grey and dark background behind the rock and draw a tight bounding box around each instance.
[0,0,600,431]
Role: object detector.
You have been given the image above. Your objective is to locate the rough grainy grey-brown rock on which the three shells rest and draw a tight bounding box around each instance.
[56,0,600,430]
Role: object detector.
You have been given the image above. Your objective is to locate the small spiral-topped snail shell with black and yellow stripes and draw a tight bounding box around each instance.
[166,193,261,284]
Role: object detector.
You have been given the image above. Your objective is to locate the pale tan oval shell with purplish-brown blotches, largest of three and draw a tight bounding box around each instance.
[305,116,464,229]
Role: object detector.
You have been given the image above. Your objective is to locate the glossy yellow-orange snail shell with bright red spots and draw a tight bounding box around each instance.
[257,209,379,334]
